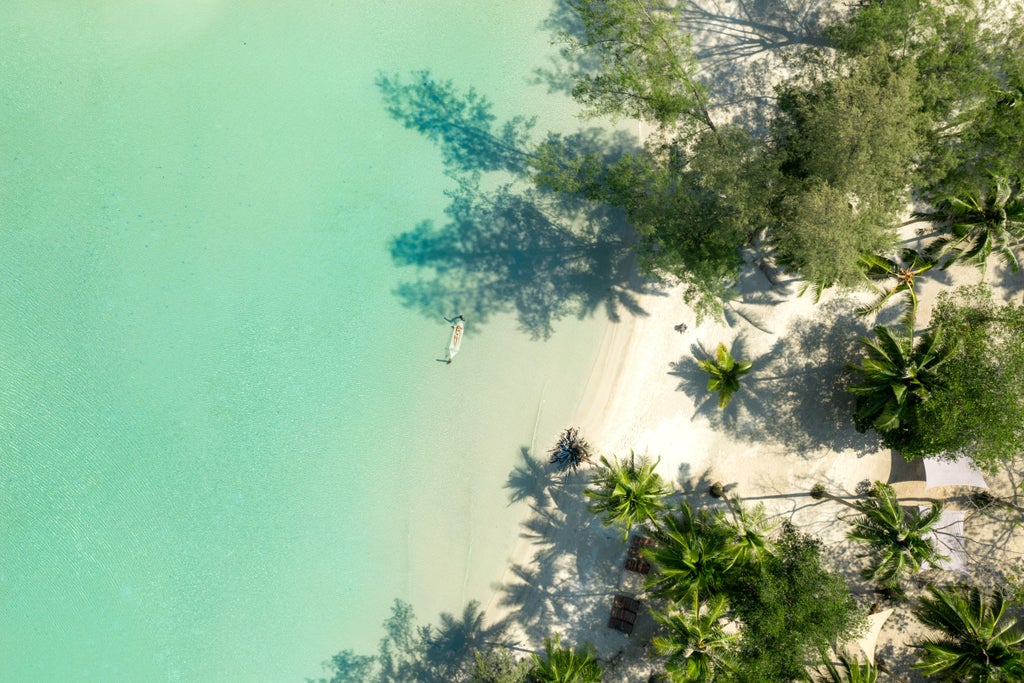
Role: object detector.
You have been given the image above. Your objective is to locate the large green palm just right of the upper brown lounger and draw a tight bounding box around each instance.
[643,503,736,612]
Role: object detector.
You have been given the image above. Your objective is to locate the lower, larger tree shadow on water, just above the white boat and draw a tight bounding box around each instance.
[391,176,651,338]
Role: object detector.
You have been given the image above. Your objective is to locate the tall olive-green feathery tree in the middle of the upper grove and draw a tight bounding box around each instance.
[767,51,923,288]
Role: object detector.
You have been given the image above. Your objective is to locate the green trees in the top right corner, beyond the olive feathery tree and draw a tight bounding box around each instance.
[825,0,1024,200]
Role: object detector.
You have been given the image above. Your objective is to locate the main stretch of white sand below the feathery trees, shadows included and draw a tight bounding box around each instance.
[485,226,1021,681]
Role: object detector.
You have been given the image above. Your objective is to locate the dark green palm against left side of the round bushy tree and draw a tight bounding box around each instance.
[848,326,953,432]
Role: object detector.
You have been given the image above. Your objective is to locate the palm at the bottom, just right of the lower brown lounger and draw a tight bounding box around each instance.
[652,596,738,683]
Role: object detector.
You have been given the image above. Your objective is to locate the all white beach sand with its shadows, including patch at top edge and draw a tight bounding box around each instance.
[486,0,1024,681]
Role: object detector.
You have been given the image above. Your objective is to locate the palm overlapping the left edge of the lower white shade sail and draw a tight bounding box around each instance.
[846,481,948,594]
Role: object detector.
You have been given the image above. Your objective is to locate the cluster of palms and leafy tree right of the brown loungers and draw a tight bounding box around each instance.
[647,504,863,682]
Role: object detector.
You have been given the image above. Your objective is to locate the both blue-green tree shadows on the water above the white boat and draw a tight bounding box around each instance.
[378,72,653,338]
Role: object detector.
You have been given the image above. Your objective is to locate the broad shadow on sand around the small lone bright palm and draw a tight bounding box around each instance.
[670,300,878,457]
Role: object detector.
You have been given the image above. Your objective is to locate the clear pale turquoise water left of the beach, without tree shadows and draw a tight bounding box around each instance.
[0,0,606,682]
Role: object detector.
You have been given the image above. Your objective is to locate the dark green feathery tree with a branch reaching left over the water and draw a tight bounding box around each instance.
[530,126,777,318]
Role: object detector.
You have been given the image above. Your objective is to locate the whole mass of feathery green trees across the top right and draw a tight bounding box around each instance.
[536,0,1024,314]
